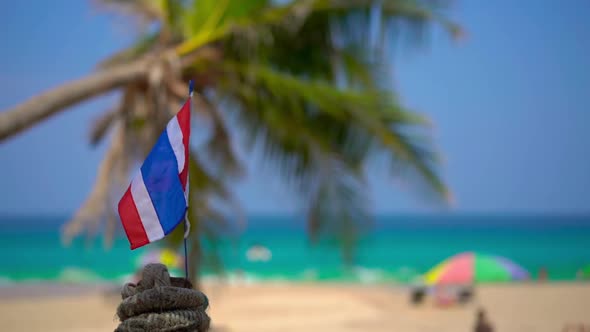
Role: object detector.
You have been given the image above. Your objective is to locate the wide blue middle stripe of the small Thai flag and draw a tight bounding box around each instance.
[141,131,186,234]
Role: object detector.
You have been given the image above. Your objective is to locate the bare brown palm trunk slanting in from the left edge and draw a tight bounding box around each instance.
[0,61,148,141]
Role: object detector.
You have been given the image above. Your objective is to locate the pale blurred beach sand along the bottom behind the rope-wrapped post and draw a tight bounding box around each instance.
[0,283,590,332]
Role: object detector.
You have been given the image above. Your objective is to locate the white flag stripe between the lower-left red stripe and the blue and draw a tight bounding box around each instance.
[131,174,164,242]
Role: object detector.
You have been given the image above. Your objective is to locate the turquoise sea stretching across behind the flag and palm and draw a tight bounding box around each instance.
[0,215,590,285]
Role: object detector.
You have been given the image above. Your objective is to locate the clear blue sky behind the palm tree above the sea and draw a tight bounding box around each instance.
[0,0,590,214]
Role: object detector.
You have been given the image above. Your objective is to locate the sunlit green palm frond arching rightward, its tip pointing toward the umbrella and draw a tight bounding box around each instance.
[227,61,438,188]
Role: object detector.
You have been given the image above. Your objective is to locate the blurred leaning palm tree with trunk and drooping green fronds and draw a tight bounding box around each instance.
[0,0,460,286]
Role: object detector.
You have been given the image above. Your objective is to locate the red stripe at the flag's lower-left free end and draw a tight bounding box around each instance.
[118,186,150,250]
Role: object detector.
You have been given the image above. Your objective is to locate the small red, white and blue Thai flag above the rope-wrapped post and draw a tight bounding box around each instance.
[119,98,191,249]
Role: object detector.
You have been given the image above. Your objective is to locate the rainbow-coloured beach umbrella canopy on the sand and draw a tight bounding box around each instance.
[424,252,529,285]
